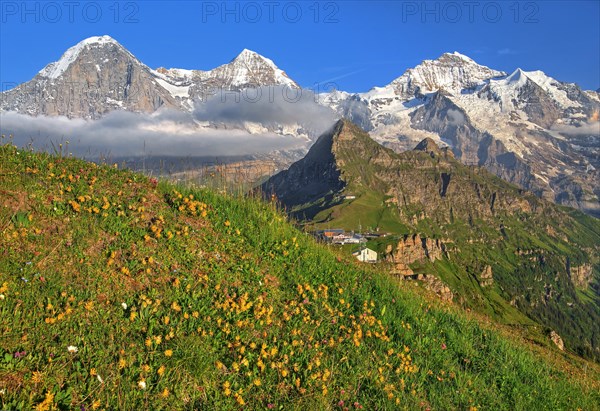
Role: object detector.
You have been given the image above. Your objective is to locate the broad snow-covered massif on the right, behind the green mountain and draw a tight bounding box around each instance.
[321,53,600,216]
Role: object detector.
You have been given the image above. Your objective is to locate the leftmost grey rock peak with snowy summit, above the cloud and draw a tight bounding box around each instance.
[0,36,180,119]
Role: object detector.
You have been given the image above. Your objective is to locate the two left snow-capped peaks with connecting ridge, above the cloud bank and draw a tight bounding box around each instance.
[0,36,298,119]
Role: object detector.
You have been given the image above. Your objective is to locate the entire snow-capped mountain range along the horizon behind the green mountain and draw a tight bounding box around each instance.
[0,36,600,216]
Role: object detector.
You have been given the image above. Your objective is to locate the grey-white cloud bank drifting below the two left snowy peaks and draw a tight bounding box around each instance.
[0,89,335,158]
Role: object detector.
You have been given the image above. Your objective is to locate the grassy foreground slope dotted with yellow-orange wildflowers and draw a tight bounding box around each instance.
[0,145,600,410]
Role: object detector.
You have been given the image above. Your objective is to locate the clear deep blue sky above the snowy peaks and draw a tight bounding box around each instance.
[0,0,600,92]
